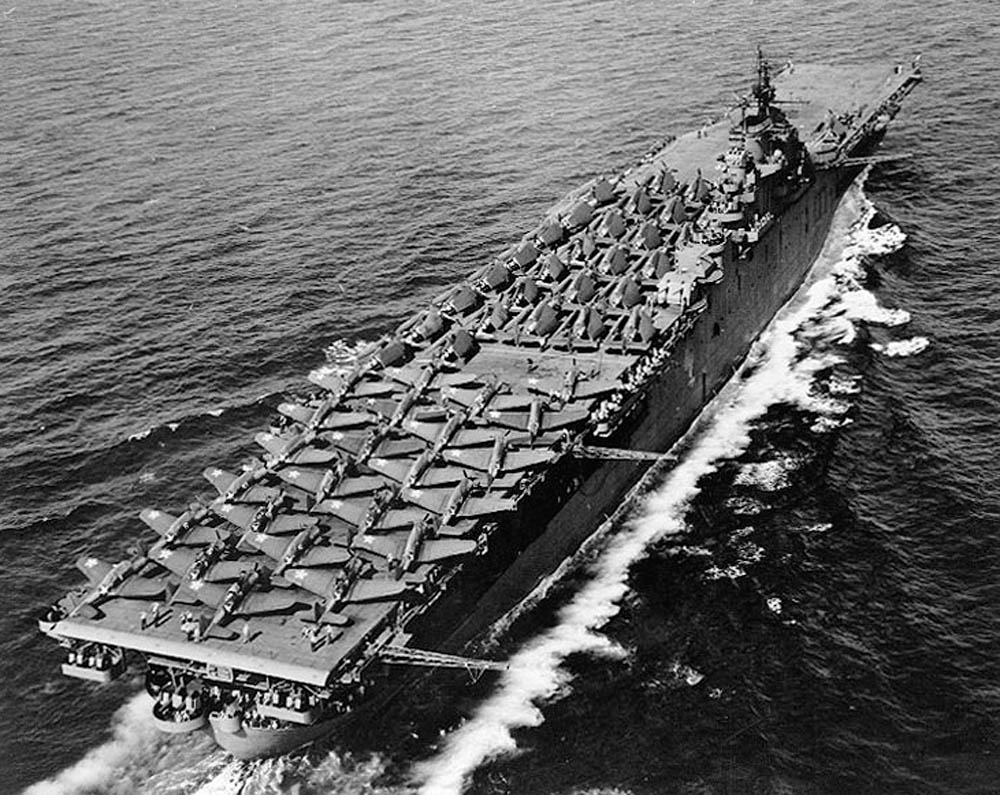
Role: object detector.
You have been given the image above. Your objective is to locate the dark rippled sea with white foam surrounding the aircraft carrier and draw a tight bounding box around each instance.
[0,0,1000,795]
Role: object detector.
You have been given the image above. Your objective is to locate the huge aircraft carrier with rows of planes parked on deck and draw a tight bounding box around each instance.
[39,54,921,758]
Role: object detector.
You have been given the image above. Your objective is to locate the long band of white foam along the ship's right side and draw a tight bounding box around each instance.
[413,181,908,795]
